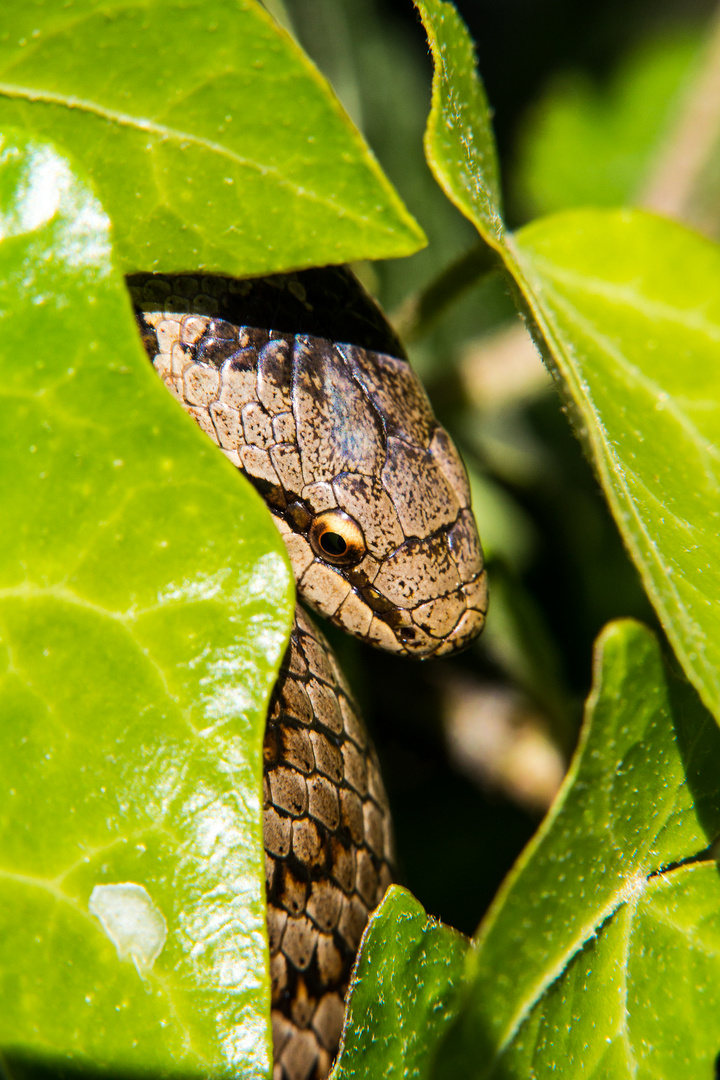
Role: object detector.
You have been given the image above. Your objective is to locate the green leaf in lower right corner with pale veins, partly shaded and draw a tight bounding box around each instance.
[434,621,720,1080]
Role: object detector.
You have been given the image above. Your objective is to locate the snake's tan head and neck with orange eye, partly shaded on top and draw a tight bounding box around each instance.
[133,268,487,657]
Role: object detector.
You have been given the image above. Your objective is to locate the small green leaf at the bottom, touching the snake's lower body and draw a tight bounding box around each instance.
[330,886,468,1080]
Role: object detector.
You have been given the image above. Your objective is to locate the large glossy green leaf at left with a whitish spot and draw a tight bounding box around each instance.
[0,133,293,1077]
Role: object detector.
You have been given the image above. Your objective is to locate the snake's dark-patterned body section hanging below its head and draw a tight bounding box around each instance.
[264,608,393,1080]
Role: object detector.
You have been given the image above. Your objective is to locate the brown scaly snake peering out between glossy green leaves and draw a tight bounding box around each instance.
[128,267,487,1080]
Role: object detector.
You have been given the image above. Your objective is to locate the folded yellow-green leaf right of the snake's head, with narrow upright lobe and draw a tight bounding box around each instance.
[414,0,720,720]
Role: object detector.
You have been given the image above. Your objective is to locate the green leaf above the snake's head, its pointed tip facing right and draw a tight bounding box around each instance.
[0,0,424,276]
